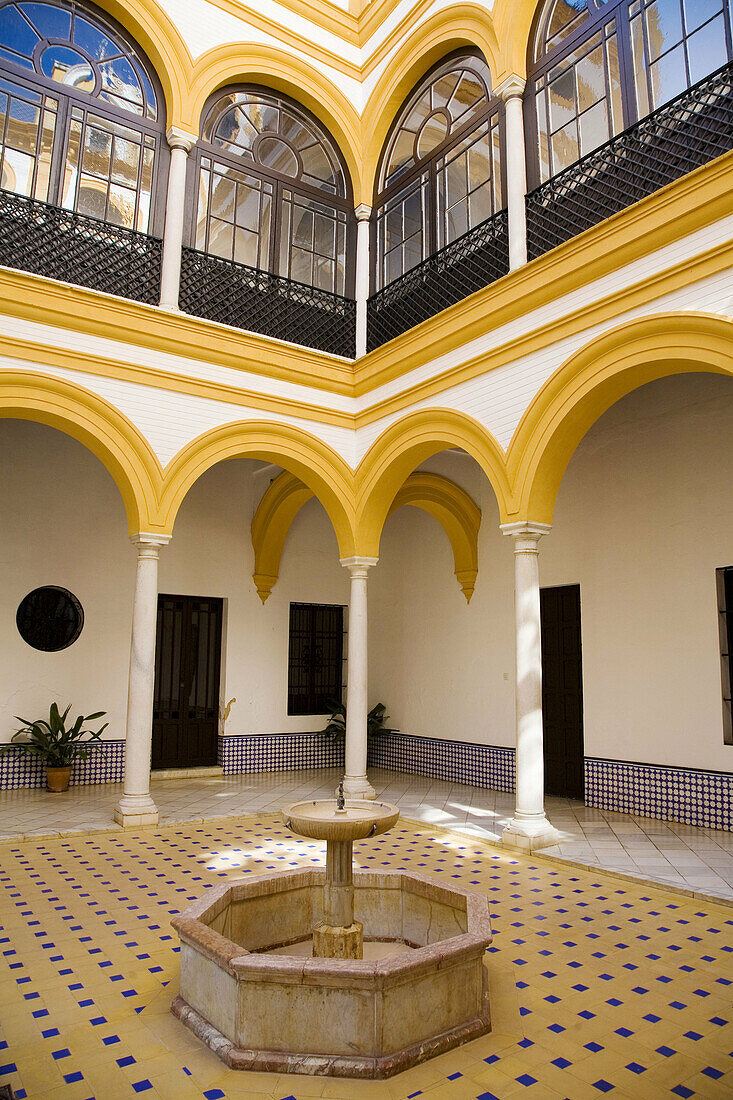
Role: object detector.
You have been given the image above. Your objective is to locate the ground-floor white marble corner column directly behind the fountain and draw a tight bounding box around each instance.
[341,558,378,799]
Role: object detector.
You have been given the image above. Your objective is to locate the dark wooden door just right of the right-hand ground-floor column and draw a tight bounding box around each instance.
[539,584,584,799]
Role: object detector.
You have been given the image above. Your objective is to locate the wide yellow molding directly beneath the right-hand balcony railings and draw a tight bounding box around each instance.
[354,152,733,396]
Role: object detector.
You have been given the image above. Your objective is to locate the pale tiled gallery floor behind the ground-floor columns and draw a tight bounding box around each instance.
[0,769,733,900]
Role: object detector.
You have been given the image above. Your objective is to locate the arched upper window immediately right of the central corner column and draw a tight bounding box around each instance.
[375,54,504,289]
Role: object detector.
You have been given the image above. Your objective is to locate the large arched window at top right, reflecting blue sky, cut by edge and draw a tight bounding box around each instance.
[527,0,733,183]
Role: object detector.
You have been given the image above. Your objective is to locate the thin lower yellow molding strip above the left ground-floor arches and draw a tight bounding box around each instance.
[0,333,355,430]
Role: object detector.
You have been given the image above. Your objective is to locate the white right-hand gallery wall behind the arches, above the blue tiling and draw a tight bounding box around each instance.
[370,375,733,771]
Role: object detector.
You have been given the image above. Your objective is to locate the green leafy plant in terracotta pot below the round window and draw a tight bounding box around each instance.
[0,703,109,791]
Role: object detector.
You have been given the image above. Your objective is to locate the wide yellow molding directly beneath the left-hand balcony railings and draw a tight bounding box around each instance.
[0,267,353,395]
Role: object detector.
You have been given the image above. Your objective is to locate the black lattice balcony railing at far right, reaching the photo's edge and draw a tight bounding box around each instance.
[527,64,733,260]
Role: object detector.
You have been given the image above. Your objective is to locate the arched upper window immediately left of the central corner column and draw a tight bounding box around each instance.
[193,88,353,295]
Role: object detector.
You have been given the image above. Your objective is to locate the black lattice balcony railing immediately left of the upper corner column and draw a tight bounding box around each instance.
[178,249,357,359]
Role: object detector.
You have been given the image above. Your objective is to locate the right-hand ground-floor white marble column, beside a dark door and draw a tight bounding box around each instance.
[502,523,557,851]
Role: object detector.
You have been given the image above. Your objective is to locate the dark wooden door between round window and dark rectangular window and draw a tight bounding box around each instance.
[152,595,222,768]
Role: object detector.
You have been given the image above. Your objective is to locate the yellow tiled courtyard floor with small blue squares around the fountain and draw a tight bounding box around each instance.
[0,814,733,1100]
